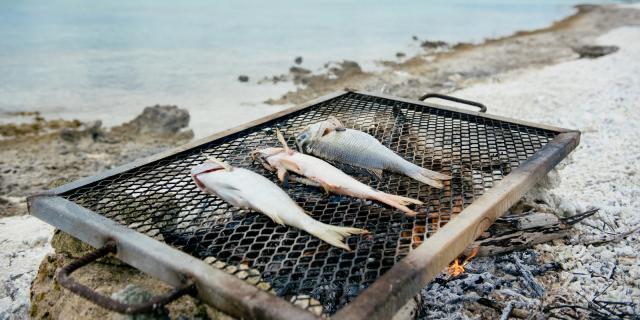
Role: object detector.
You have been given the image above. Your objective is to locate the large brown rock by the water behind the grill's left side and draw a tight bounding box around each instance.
[111,105,193,136]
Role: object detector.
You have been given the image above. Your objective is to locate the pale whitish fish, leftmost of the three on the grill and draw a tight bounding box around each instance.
[191,158,368,251]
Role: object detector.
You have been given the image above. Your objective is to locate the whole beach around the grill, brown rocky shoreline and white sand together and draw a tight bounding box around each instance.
[0,5,640,319]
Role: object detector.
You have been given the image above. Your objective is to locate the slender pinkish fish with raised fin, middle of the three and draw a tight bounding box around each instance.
[251,130,423,217]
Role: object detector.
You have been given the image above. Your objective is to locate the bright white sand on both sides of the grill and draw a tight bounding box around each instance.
[0,6,640,320]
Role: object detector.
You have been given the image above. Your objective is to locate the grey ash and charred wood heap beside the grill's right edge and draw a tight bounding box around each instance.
[412,175,640,319]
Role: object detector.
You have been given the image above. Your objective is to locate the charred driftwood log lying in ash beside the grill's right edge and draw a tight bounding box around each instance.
[464,209,598,256]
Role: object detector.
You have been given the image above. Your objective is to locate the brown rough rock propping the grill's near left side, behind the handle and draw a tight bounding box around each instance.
[29,232,232,320]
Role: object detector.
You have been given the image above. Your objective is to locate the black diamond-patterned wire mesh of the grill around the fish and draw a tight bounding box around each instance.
[62,93,556,315]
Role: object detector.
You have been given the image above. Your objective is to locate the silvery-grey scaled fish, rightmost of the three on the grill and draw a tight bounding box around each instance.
[296,116,451,188]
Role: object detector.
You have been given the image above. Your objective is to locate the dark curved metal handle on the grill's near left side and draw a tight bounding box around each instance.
[56,241,195,315]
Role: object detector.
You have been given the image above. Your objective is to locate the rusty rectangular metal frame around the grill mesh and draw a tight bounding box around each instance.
[28,90,580,319]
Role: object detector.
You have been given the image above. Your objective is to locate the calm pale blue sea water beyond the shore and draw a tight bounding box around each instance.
[0,0,616,136]
